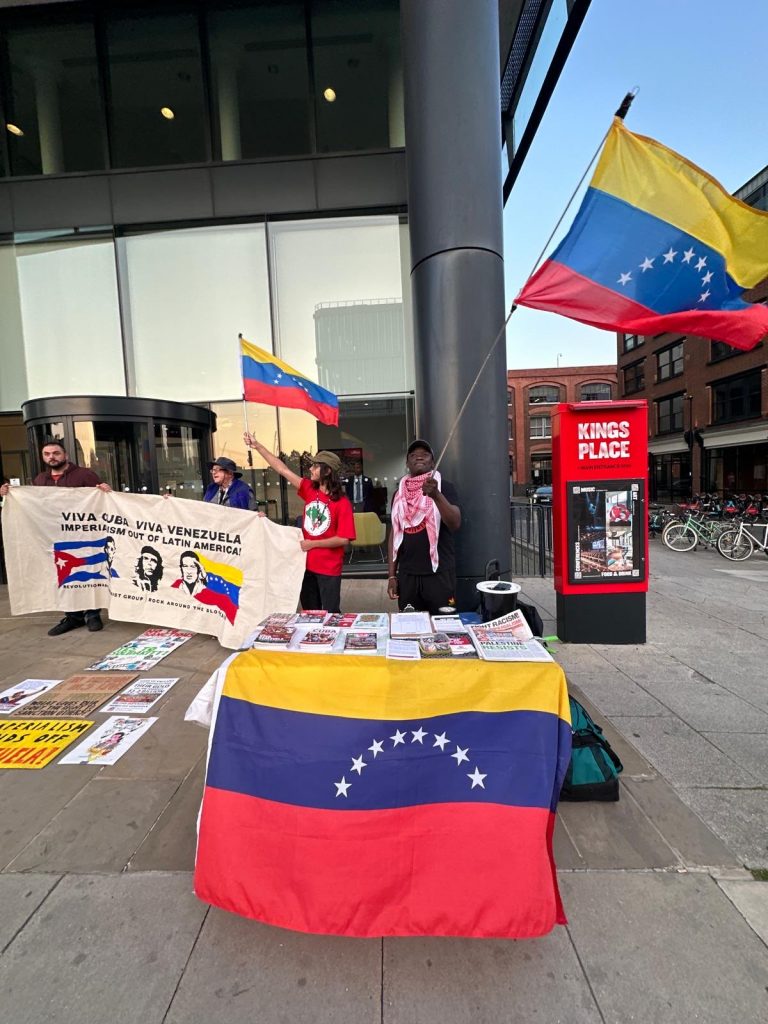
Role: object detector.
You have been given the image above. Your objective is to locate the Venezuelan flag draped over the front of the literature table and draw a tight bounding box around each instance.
[195,651,570,938]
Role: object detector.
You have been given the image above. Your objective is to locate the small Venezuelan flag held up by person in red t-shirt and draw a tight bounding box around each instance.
[240,338,339,426]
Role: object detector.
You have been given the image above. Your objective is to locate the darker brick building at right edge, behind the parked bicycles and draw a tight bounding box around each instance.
[617,167,768,502]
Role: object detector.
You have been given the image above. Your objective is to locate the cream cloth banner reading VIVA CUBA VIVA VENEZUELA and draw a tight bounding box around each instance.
[2,487,306,647]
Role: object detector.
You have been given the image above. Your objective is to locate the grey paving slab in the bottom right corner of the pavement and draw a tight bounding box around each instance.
[561,871,768,1024]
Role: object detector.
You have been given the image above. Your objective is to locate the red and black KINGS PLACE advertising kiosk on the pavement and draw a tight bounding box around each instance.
[552,401,648,643]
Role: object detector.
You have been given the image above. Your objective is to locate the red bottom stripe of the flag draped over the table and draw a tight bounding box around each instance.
[195,786,566,939]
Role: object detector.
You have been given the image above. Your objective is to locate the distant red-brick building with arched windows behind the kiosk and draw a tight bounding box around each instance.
[507,364,616,495]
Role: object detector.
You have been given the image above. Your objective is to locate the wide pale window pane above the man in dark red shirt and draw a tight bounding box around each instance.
[16,238,125,398]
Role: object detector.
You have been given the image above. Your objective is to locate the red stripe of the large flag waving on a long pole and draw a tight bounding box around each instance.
[515,260,768,350]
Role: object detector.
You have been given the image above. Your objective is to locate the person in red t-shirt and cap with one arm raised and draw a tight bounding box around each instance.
[243,431,355,611]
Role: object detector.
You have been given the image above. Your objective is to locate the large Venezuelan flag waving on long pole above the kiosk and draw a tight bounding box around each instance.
[515,118,768,349]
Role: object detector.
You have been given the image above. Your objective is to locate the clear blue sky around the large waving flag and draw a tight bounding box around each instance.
[504,0,768,370]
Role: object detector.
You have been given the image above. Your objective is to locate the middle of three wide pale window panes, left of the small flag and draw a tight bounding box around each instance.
[119,224,271,401]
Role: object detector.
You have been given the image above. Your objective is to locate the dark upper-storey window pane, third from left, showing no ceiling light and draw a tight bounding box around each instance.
[209,2,313,160]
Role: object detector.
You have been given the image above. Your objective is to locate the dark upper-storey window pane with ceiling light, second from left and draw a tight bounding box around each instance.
[106,13,208,167]
